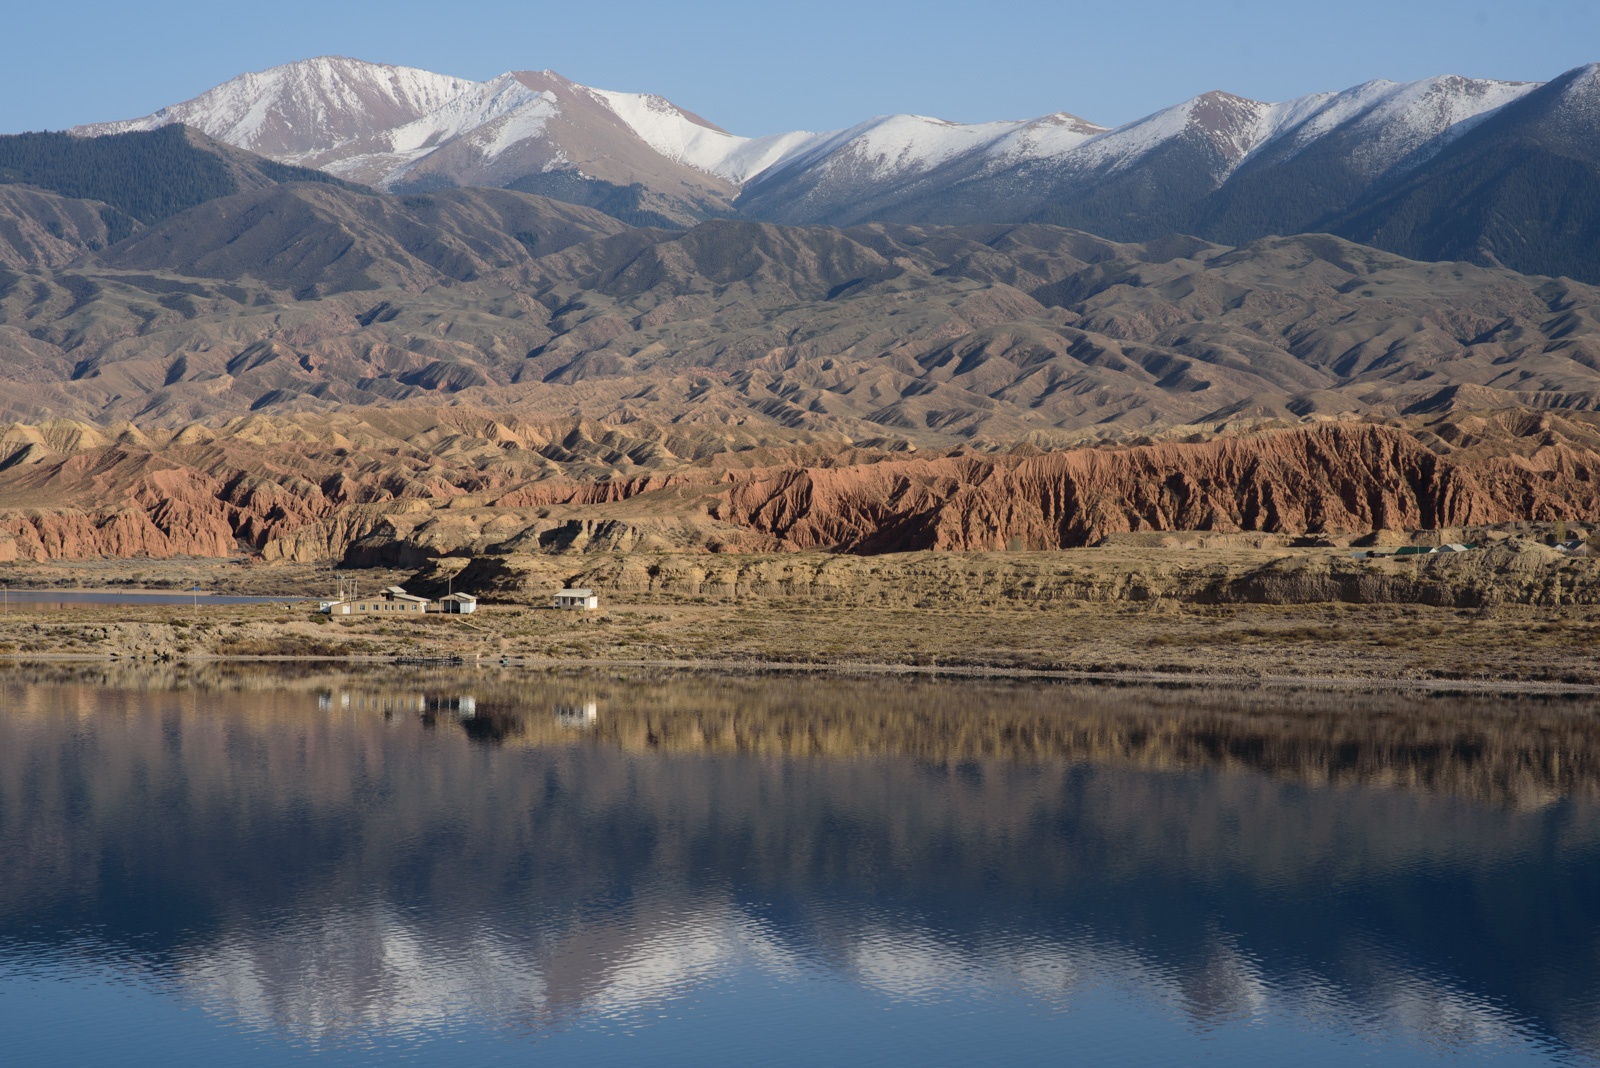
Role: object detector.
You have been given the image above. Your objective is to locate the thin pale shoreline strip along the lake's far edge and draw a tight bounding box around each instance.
[12,652,1600,697]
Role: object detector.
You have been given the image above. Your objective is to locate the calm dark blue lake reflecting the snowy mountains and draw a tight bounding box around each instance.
[0,665,1600,1068]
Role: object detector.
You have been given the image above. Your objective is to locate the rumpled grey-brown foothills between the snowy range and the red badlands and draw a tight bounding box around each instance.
[0,220,1600,434]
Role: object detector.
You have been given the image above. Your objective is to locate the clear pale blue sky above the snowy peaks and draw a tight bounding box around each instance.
[0,0,1600,134]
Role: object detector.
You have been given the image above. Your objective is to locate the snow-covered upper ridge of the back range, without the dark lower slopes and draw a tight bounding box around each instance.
[74,56,1574,225]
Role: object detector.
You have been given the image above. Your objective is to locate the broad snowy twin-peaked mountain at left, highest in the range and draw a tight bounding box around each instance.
[74,56,794,225]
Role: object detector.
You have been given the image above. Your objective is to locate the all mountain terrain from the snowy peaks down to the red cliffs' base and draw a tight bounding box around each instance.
[0,59,1600,563]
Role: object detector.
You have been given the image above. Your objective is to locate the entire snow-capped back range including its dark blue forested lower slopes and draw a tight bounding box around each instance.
[74,58,1600,281]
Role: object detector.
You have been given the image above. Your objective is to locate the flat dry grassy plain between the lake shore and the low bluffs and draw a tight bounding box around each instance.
[0,558,1600,687]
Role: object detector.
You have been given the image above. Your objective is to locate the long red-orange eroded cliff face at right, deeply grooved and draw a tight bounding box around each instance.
[717,424,1600,553]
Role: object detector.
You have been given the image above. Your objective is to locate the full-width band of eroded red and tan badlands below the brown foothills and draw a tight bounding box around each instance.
[0,412,1600,566]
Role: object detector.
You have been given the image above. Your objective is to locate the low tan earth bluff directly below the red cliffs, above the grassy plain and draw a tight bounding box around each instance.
[444,545,1600,609]
